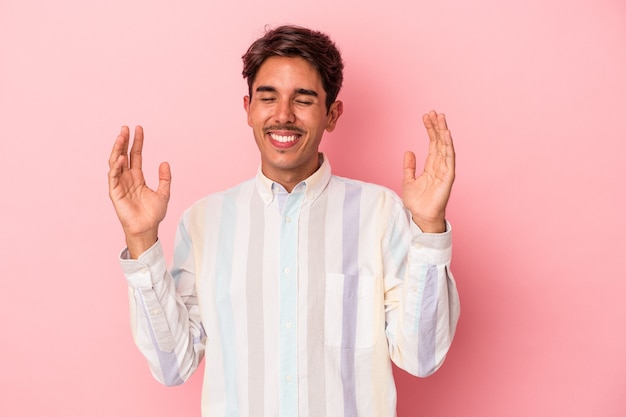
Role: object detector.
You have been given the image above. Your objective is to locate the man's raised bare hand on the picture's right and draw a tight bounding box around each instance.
[402,110,454,233]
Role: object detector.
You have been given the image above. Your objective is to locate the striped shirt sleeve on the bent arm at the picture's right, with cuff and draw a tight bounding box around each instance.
[385,210,460,377]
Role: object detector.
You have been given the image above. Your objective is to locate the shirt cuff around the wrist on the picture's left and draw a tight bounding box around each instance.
[119,240,167,288]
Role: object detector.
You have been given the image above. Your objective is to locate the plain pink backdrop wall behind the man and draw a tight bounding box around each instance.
[0,0,626,417]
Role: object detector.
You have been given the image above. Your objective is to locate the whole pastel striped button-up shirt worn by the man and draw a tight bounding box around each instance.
[120,155,459,417]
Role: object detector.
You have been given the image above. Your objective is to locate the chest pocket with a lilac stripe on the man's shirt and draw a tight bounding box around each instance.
[324,274,383,349]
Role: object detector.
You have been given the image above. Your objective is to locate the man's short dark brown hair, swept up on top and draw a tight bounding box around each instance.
[241,26,343,110]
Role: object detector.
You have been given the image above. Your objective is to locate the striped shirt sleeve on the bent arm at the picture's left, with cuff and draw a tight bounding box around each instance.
[120,216,206,386]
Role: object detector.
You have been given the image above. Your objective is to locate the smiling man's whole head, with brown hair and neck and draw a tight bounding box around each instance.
[243,26,343,191]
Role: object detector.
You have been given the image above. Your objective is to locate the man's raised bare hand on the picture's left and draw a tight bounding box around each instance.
[109,126,172,259]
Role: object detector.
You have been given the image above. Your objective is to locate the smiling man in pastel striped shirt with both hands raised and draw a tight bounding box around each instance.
[109,26,459,417]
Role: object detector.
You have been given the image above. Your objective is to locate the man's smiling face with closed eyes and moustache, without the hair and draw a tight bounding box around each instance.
[244,56,343,191]
